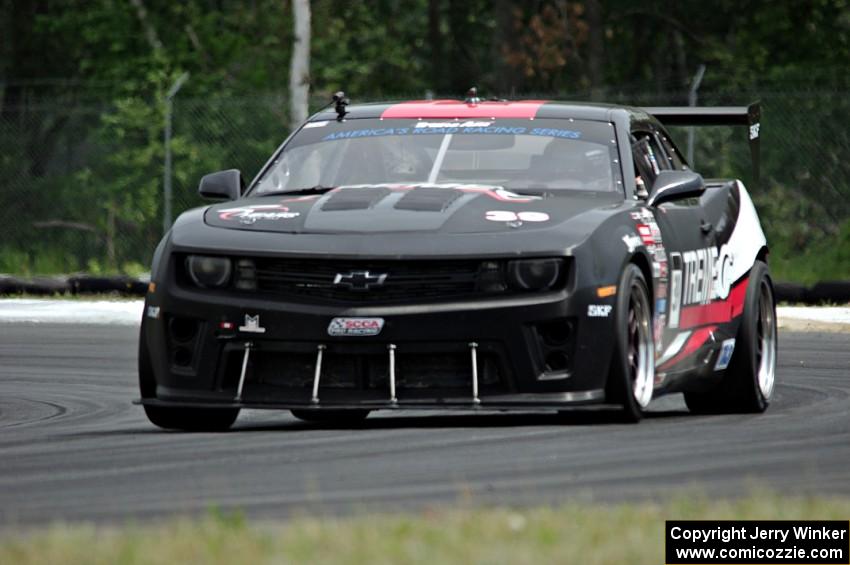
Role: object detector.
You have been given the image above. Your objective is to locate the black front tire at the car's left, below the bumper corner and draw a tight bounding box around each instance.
[139,322,239,432]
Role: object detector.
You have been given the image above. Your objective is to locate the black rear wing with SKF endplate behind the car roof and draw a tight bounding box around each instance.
[644,102,761,182]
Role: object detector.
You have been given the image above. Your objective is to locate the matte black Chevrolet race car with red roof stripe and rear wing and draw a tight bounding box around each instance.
[139,95,777,429]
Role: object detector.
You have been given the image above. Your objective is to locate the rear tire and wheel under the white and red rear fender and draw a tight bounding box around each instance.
[685,261,778,414]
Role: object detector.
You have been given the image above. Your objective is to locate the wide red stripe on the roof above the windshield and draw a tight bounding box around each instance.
[381,100,546,120]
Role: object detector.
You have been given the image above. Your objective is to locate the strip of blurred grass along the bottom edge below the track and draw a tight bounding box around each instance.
[0,493,850,565]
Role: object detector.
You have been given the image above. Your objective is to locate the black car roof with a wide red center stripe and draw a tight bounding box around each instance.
[309,100,650,121]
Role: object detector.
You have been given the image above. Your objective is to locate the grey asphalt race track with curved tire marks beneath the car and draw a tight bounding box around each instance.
[0,324,850,527]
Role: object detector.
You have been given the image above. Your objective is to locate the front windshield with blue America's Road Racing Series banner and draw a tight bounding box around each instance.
[252,119,621,194]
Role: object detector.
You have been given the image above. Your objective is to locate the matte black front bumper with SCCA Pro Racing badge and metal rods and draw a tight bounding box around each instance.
[140,284,611,410]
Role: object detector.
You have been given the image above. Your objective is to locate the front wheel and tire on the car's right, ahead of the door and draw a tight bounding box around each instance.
[605,263,655,422]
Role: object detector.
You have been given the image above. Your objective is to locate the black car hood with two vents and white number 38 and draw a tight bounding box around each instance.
[204,184,623,234]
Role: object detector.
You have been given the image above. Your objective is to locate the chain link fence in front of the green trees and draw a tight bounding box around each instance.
[0,88,850,278]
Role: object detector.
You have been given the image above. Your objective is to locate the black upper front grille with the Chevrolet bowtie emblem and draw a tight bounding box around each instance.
[250,259,481,303]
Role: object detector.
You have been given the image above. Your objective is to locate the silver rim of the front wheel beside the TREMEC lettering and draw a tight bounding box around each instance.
[626,284,655,408]
